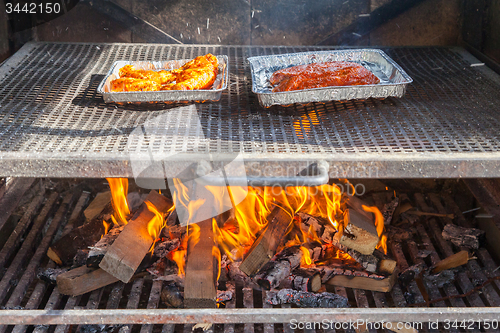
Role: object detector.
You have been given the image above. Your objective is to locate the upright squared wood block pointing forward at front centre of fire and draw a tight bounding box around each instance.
[184,219,218,308]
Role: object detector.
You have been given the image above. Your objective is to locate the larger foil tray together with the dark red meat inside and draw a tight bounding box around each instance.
[248,49,413,107]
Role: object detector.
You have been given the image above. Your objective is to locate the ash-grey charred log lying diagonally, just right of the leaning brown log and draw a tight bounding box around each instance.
[255,243,321,290]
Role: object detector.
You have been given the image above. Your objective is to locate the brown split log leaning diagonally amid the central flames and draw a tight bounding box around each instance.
[240,206,292,276]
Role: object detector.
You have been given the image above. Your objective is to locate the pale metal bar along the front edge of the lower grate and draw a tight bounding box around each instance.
[0,307,498,325]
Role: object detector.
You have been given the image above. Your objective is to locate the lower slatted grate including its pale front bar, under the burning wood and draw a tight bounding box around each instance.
[0,180,500,333]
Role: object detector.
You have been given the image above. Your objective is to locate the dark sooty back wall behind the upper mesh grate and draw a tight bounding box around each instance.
[0,0,500,67]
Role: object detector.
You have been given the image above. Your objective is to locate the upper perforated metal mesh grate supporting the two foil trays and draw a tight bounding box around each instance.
[0,43,500,178]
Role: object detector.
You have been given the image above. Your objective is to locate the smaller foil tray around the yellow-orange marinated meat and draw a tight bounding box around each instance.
[97,55,229,103]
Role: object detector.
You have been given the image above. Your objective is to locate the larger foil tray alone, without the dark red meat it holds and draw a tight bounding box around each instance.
[248,49,413,107]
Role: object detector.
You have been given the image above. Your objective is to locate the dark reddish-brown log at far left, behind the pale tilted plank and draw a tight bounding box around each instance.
[47,203,113,266]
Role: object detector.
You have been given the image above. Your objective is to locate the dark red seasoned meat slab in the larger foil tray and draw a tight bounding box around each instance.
[269,61,380,92]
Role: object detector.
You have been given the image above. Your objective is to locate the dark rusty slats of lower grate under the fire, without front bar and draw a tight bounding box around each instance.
[0,180,500,333]
